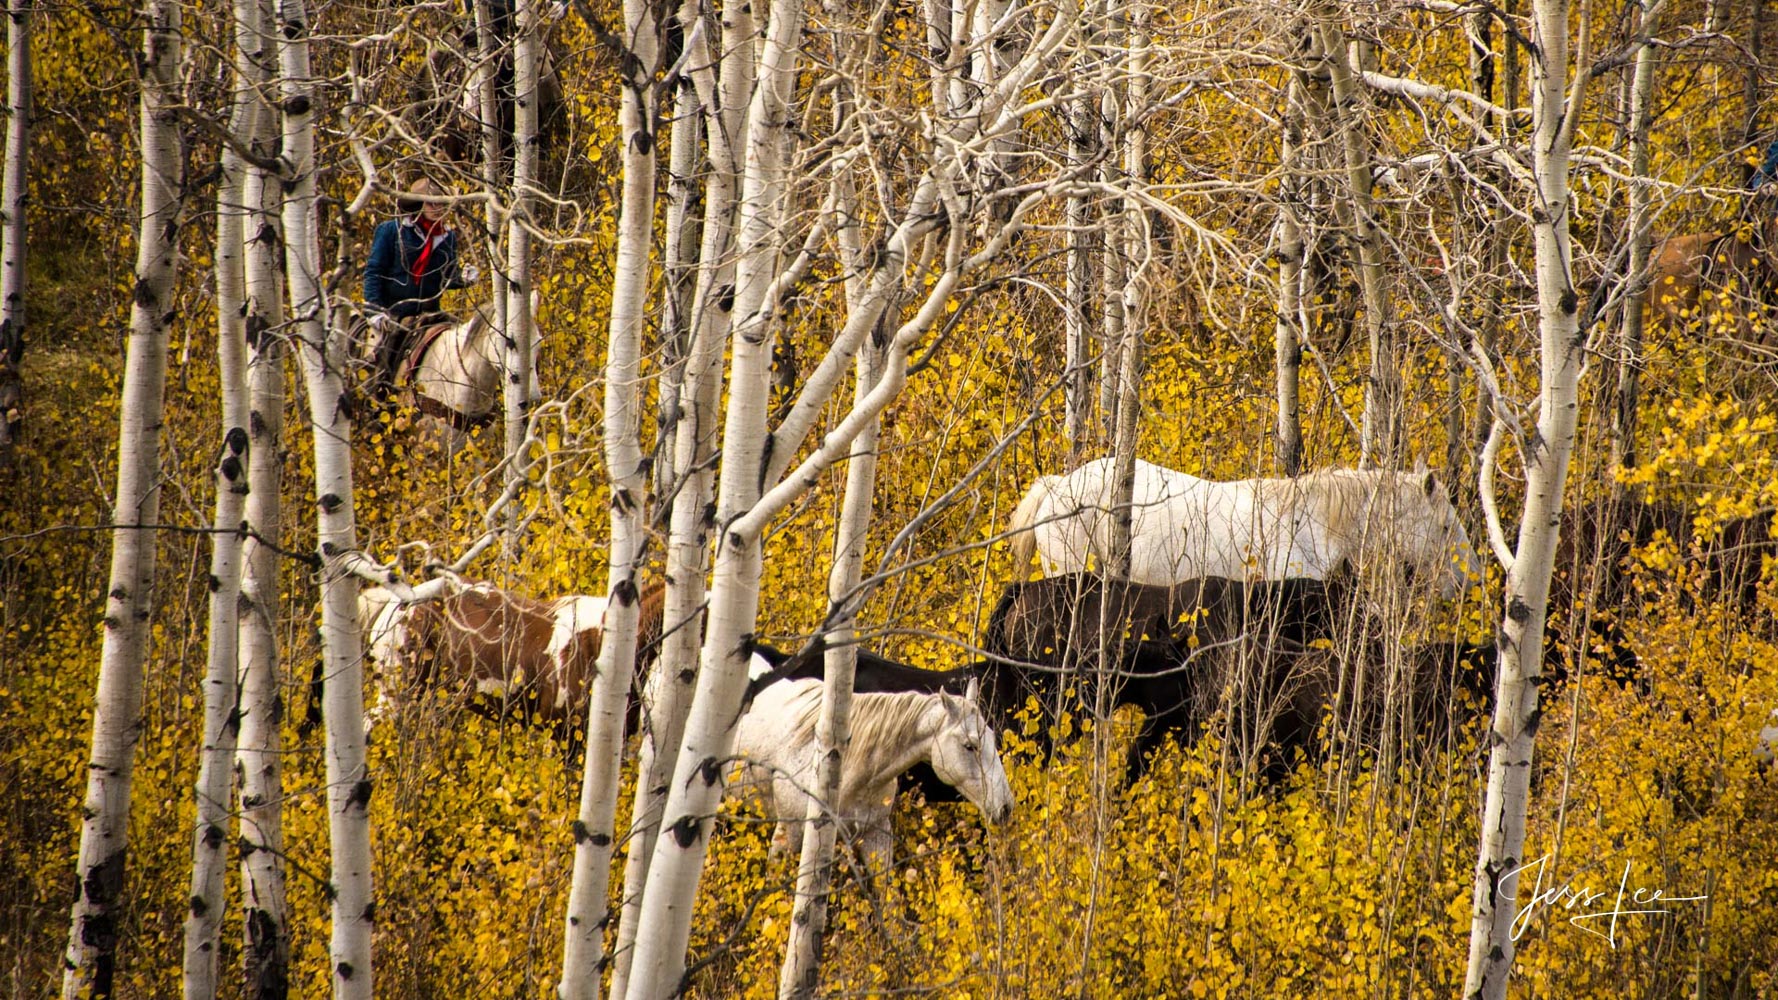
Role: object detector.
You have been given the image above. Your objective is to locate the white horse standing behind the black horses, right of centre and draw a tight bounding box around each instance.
[1008,459,1481,598]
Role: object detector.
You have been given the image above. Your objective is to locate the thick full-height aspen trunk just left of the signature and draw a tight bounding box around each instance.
[1463,0,1586,1000]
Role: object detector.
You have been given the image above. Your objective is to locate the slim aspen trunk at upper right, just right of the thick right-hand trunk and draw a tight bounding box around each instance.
[1611,0,1661,468]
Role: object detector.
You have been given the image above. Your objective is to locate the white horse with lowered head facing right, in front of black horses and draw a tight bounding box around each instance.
[734,657,1013,868]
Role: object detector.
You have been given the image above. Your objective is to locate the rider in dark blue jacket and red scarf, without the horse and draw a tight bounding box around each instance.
[364,178,480,393]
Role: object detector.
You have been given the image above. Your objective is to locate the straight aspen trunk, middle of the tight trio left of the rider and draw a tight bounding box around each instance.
[235,0,290,1000]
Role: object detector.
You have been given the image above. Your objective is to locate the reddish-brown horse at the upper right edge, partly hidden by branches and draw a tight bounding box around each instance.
[1643,219,1778,349]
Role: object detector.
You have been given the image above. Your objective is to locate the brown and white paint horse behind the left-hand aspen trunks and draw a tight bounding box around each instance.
[359,584,665,735]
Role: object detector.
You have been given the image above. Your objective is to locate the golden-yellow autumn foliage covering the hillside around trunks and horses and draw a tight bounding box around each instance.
[0,4,1778,996]
